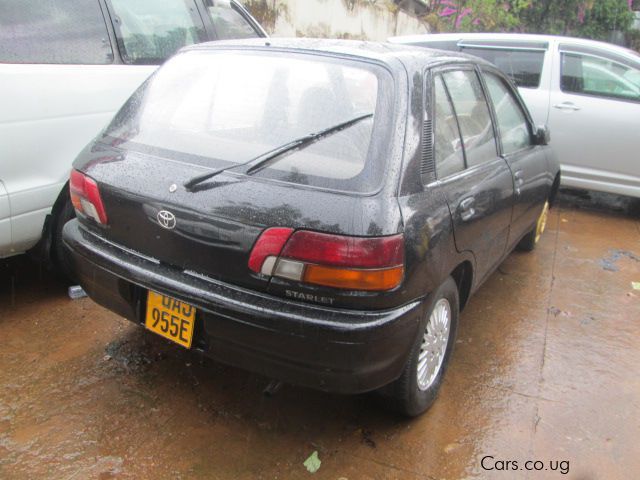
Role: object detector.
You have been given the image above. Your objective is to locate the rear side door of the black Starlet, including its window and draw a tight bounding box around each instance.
[432,66,513,282]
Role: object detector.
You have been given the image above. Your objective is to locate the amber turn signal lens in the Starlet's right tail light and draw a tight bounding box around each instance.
[304,265,404,291]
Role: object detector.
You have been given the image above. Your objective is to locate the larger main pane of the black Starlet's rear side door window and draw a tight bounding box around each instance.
[442,70,498,167]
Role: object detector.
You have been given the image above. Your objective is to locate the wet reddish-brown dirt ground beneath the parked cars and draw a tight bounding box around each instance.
[0,192,640,480]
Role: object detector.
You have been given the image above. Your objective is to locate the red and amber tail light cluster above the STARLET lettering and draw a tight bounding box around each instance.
[249,228,404,291]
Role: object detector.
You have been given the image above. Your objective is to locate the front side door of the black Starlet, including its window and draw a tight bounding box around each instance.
[482,71,549,246]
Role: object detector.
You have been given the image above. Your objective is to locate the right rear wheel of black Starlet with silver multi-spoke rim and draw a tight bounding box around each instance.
[379,277,460,417]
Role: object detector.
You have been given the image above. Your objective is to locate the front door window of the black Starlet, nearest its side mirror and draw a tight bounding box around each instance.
[484,73,531,155]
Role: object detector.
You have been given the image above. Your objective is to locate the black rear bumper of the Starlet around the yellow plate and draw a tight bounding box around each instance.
[63,220,423,393]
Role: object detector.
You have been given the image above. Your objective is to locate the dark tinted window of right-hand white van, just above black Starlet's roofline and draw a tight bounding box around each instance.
[462,47,545,88]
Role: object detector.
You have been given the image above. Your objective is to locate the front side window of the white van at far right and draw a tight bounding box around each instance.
[560,52,640,101]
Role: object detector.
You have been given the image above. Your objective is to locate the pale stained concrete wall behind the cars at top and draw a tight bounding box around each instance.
[242,0,428,40]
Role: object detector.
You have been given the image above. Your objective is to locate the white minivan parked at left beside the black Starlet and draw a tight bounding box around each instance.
[0,0,266,272]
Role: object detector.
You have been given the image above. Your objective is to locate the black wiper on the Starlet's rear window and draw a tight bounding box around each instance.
[184,113,373,192]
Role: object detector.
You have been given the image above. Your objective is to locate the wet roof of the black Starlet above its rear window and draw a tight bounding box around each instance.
[183,38,490,70]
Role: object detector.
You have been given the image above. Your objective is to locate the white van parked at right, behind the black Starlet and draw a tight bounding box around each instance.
[390,33,640,197]
